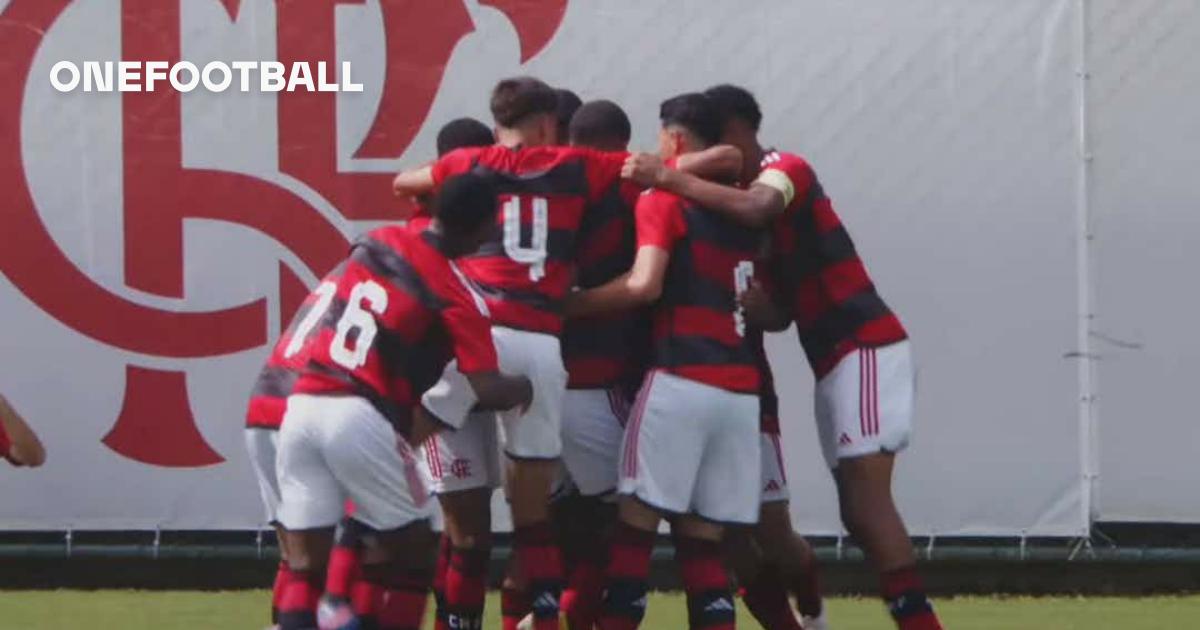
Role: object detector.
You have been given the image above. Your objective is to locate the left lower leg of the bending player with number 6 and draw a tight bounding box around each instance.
[278,527,334,630]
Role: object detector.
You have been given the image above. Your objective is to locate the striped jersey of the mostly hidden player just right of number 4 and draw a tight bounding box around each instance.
[563,181,650,389]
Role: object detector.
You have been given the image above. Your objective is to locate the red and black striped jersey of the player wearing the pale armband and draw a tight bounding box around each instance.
[756,150,907,378]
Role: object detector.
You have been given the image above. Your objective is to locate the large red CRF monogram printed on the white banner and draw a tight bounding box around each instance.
[0,0,566,467]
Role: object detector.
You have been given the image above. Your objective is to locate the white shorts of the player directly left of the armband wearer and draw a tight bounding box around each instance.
[618,370,761,524]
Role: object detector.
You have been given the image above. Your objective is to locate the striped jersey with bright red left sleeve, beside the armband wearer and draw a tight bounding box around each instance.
[637,191,763,394]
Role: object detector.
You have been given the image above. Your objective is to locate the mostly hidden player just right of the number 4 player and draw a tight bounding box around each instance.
[542,101,649,630]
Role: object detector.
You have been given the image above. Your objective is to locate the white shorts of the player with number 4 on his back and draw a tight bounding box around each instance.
[421,326,566,490]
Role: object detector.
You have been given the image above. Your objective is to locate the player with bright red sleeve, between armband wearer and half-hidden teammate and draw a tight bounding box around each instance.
[568,94,763,630]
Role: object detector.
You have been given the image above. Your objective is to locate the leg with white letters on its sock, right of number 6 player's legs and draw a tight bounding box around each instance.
[437,487,492,630]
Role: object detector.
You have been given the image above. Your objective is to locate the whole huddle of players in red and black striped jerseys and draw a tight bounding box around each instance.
[246,77,941,630]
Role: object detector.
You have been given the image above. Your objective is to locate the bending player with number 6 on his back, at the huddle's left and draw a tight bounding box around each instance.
[276,174,532,630]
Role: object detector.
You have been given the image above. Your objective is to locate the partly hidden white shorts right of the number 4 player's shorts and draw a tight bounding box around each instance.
[563,389,630,497]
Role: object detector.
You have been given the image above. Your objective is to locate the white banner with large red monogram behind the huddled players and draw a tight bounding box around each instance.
[0,0,1185,535]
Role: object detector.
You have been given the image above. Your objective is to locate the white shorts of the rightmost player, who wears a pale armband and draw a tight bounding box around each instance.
[815,341,914,468]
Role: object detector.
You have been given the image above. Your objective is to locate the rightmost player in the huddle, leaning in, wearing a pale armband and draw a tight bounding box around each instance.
[628,85,941,630]
